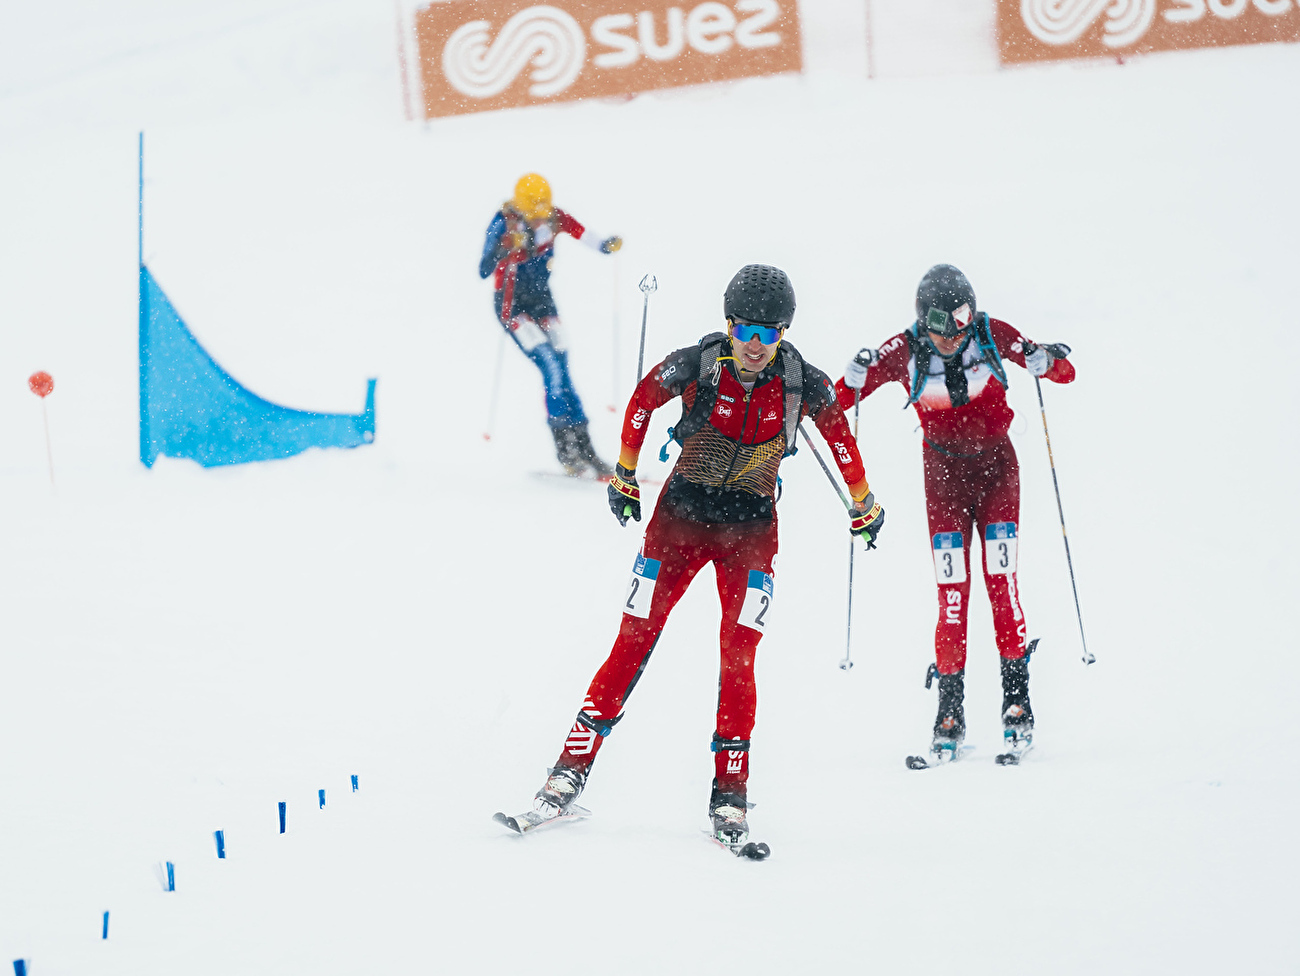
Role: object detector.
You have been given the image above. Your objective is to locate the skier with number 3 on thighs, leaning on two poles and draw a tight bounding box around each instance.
[836,264,1074,762]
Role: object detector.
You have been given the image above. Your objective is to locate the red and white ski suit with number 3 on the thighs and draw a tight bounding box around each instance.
[836,318,1074,674]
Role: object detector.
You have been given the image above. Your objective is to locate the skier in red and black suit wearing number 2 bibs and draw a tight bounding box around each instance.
[517,265,884,850]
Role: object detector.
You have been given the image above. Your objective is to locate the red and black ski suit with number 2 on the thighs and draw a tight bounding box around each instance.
[558,337,868,795]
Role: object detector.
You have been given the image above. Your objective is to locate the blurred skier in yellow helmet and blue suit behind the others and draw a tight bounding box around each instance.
[478,173,623,478]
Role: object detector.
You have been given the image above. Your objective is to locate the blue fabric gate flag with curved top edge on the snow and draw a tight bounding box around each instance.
[140,264,374,468]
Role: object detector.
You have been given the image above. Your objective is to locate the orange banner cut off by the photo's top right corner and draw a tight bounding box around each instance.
[997,0,1300,64]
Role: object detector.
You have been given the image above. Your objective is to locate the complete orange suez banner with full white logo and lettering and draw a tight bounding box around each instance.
[415,0,803,118]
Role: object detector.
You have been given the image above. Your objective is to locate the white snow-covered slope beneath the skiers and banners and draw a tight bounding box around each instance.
[0,0,1300,976]
